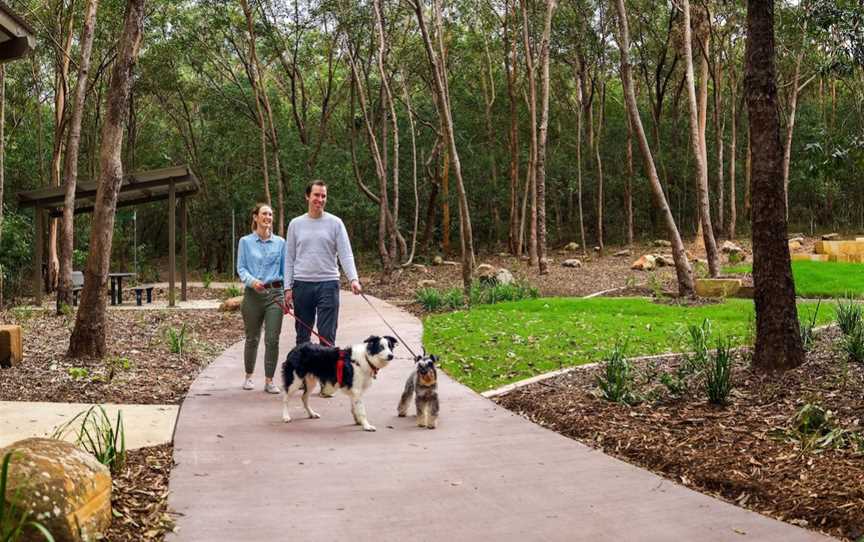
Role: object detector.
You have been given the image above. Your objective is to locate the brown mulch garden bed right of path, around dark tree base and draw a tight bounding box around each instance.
[497,328,864,540]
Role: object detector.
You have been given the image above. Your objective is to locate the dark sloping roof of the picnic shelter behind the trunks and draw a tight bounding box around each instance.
[18,165,201,216]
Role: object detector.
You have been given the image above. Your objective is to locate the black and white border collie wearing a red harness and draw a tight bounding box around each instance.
[282,335,398,431]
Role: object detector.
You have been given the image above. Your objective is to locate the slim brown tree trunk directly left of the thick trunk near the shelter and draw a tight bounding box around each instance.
[57,0,99,314]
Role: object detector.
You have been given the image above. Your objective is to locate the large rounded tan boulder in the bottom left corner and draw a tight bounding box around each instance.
[0,438,111,542]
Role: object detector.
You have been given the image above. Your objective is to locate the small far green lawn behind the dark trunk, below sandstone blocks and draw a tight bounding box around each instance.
[723,261,864,297]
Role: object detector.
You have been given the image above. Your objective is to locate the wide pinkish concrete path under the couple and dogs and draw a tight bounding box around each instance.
[169,293,827,542]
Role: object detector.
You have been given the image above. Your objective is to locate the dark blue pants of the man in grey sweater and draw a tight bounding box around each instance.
[293,280,339,346]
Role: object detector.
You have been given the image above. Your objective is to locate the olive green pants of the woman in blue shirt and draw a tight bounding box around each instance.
[240,288,285,378]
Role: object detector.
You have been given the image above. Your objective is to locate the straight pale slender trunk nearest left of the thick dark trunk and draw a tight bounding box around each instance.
[681,0,720,277]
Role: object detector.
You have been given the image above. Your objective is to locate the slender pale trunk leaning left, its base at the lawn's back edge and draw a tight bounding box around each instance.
[615,0,694,297]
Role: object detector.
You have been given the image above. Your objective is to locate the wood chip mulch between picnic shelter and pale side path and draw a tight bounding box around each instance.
[0,309,243,404]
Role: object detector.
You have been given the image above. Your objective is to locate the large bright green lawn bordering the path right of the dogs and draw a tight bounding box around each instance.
[423,298,834,391]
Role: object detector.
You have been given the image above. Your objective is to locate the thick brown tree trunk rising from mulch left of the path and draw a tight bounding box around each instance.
[69,0,144,358]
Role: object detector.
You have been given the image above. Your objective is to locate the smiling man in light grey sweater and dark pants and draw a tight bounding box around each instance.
[285,180,363,354]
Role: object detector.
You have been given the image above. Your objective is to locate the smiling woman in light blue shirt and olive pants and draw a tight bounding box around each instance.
[237,203,285,393]
